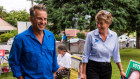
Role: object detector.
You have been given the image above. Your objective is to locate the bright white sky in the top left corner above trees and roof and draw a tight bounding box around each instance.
[0,0,35,13]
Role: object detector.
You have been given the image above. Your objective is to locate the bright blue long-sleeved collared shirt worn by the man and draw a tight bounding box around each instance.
[8,27,59,79]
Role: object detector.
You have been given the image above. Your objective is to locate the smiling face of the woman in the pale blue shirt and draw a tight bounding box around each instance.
[96,20,110,32]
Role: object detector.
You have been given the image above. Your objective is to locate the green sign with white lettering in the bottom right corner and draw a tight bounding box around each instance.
[126,60,140,79]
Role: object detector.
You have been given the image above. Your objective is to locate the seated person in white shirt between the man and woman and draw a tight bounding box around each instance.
[55,44,71,79]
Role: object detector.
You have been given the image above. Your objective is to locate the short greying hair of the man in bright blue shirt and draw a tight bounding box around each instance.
[30,4,47,17]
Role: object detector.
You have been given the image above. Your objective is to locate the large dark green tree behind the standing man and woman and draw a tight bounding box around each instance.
[37,0,140,48]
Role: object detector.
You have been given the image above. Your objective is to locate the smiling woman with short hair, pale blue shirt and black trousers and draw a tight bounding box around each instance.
[81,10,126,79]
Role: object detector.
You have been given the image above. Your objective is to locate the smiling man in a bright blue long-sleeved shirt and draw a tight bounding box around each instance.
[9,4,59,79]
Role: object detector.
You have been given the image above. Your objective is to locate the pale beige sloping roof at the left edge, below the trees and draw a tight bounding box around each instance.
[0,18,17,32]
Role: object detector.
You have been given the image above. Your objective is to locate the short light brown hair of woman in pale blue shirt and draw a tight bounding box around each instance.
[95,10,113,24]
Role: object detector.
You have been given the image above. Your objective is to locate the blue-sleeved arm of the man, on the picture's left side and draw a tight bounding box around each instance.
[8,37,22,78]
